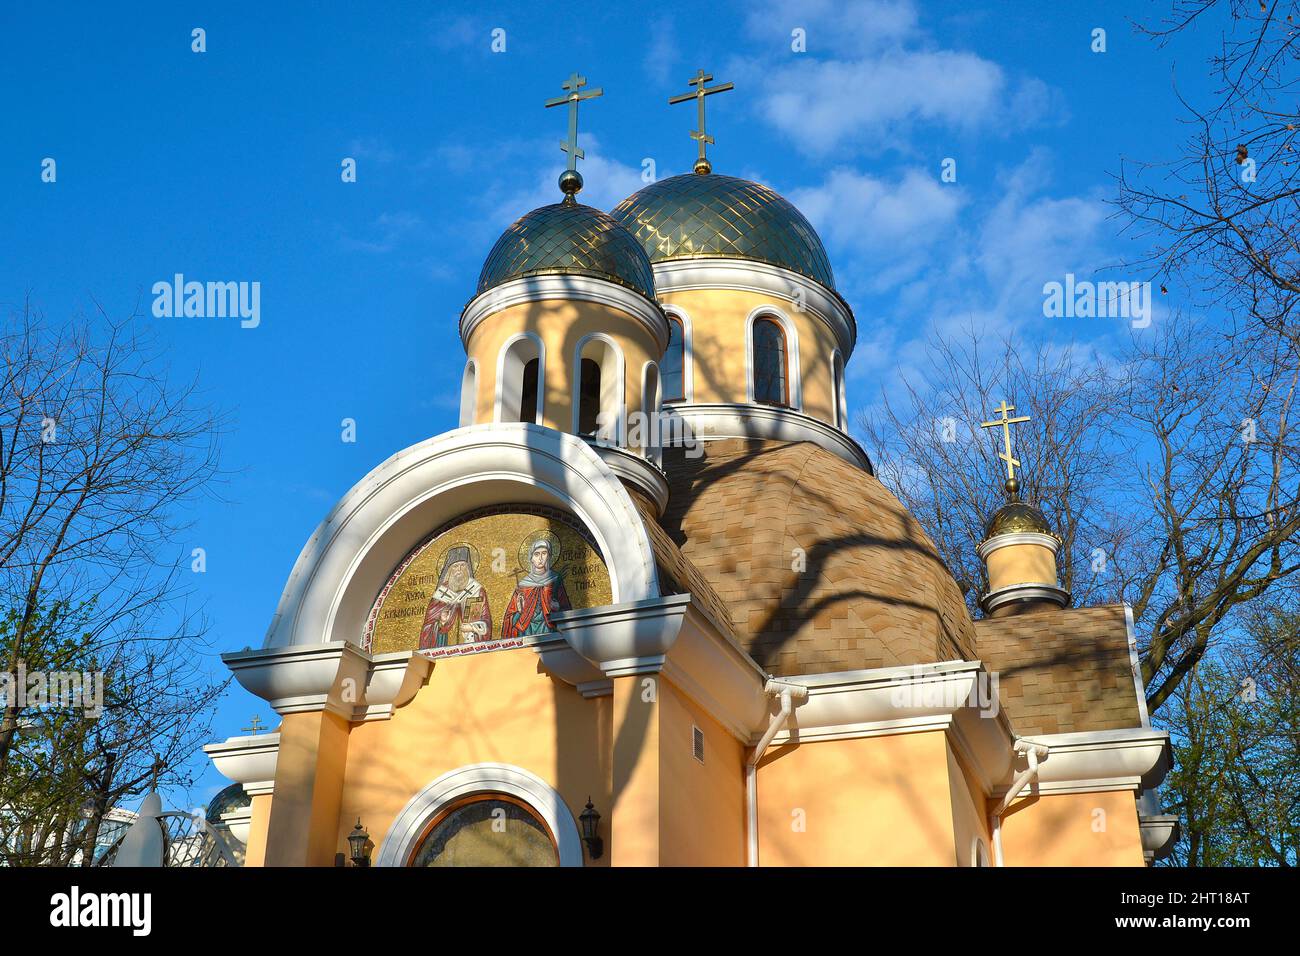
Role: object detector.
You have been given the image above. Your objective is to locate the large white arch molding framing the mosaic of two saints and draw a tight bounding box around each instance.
[263,423,659,648]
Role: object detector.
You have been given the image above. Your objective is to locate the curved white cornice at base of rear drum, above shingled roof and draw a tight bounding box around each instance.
[663,402,875,475]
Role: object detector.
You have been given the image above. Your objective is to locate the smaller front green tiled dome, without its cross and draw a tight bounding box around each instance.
[478,203,654,300]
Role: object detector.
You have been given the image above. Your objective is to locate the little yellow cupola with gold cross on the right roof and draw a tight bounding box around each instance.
[979,401,1070,618]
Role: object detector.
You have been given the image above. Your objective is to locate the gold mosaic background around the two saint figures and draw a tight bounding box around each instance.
[368,509,614,654]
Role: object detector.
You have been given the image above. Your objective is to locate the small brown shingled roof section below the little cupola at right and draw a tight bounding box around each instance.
[975,605,1143,735]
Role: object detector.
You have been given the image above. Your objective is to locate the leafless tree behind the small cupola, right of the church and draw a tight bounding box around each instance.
[862,316,1300,711]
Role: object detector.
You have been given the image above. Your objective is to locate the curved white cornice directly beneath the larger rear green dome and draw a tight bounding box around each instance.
[654,256,858,362]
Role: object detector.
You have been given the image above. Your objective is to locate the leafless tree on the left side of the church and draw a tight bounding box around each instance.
[0,297,222,847]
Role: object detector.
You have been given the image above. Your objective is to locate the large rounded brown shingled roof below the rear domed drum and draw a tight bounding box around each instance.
[657,438,976,676]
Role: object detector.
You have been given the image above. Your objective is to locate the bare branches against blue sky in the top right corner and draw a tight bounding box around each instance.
[1117,0,1300,346]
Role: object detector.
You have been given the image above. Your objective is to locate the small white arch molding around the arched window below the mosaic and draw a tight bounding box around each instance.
[374,763,582,866]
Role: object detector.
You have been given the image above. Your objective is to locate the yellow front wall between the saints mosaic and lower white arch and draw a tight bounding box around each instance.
[335,649,611,865]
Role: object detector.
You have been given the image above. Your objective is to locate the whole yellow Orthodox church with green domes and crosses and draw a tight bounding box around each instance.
[204,70,1175,866]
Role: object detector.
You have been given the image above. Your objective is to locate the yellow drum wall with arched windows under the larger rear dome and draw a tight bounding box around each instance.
[663,289,848,425]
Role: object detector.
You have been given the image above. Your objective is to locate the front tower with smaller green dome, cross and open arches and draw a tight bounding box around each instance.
[460,73,668,484]
